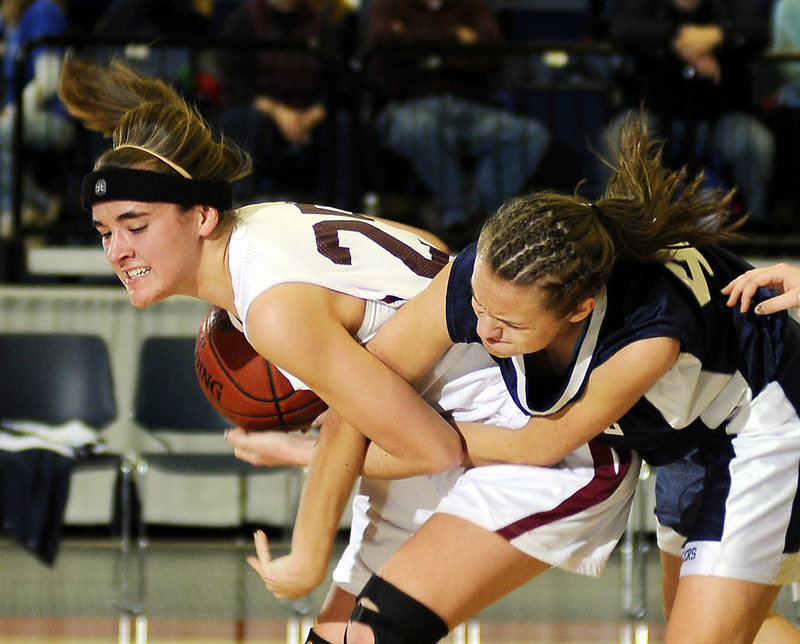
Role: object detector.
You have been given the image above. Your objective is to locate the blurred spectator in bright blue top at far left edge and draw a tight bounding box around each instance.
[0,0,75,237]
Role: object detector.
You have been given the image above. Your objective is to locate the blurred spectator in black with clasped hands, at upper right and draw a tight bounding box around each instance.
[601,0,775,230]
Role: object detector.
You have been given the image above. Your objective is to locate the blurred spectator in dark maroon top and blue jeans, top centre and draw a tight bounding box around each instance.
[367,0,551,248]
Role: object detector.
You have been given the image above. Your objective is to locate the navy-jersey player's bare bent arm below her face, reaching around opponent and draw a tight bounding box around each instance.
[459,337,680,466]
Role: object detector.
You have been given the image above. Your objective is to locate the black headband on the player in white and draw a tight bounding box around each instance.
[81,168,233,210]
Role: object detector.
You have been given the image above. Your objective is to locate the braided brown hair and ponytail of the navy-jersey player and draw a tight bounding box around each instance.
[478,116,741,314]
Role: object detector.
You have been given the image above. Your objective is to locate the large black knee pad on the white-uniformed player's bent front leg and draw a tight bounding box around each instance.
[345,575,449,644]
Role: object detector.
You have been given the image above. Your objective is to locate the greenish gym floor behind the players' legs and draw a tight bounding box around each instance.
[0,535,796,644]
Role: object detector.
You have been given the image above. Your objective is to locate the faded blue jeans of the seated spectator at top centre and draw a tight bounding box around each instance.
[377,95,550,227]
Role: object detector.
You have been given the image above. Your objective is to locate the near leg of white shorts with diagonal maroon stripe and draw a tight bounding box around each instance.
[436,443,641,577]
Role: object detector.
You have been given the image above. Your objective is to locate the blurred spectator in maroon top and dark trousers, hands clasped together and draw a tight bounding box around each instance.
[217,0,352,201]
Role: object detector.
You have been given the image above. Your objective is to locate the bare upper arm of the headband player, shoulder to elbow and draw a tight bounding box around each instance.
[247,284,463,476]
